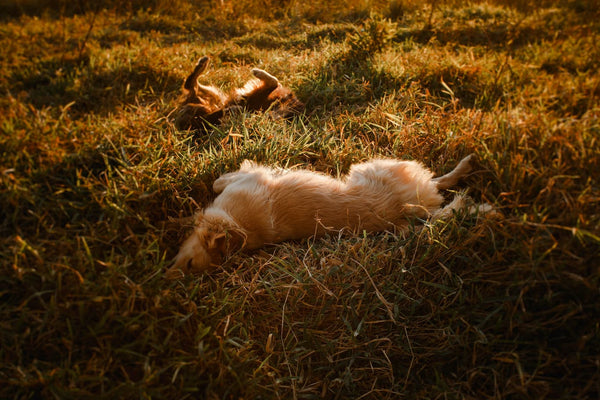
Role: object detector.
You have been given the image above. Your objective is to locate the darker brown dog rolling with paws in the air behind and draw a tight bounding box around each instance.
[175,56,304,131]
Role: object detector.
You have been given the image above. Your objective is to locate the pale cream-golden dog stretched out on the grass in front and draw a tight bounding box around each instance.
[166,156,490,279]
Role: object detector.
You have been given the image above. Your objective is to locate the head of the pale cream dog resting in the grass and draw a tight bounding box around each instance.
[165,216,245,279]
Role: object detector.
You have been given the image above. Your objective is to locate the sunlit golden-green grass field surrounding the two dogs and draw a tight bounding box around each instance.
[0,0,600,399]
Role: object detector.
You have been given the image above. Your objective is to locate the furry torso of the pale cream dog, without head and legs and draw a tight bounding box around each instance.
[215,164,442,245]
